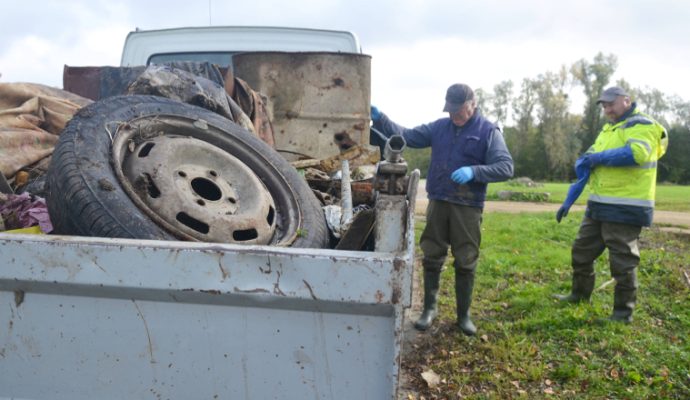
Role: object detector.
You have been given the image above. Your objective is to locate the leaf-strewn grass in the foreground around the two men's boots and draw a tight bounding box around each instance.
[403,212,690,399]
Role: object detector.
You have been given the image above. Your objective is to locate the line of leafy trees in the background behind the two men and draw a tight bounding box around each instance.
[406,53,690,184]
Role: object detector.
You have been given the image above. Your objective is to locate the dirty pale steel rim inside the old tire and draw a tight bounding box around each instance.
[109,115,300,245]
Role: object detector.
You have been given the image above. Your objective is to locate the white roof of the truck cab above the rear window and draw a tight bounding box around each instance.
[120,26,361,66]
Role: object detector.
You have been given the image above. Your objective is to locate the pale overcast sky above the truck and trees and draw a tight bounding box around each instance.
[0,0,690,126]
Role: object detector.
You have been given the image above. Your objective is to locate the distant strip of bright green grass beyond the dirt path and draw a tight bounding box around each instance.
[487,182,690,211]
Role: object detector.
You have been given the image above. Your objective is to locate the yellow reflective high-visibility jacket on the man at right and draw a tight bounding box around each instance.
[587,103,668,209]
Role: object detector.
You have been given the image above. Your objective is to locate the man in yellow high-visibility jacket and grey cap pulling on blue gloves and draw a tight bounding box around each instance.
[555,87,668,323]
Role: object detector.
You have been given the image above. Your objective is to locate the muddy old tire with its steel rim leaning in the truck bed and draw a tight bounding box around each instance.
[46,96,328,248]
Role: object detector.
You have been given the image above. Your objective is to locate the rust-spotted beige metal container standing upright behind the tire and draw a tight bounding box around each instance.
[233,52,371,161]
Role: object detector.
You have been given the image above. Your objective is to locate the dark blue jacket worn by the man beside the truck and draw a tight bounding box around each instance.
[374,110,513,208]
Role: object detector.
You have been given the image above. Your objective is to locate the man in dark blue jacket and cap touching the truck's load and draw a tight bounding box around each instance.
[371,83,513,335]
